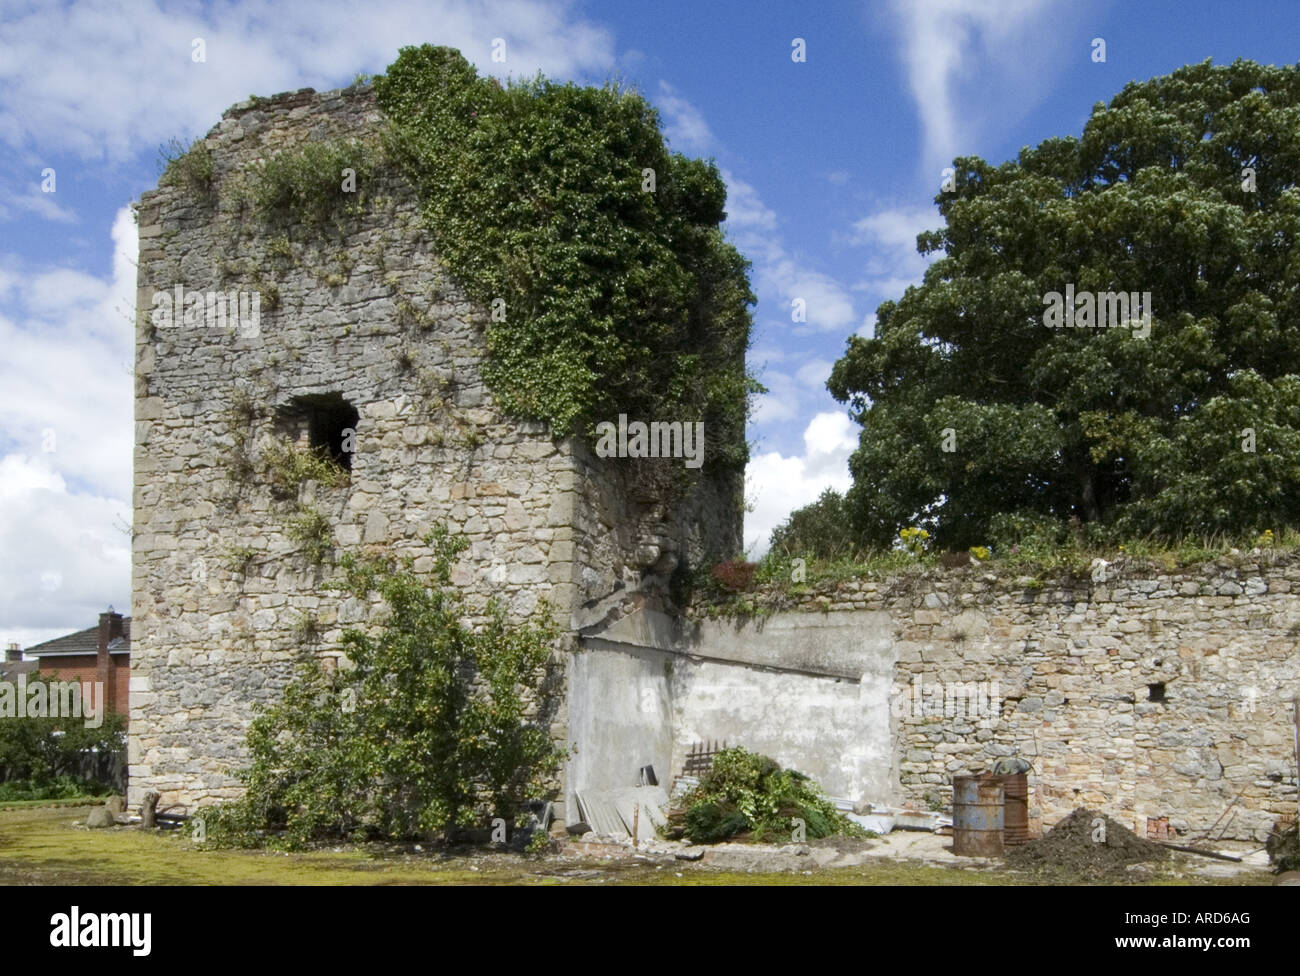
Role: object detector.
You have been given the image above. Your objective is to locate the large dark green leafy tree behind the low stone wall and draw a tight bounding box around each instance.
[828,61,1300,546]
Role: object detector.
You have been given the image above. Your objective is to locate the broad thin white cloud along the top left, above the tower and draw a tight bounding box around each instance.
[0,0,614,160]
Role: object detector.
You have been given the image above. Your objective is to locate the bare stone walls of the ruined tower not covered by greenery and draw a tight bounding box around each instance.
[129,90,740,806]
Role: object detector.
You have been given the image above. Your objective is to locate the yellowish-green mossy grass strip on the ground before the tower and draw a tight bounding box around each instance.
[0,803,1271,885]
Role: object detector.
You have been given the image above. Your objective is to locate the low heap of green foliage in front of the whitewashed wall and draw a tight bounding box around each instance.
[685,749,866,843]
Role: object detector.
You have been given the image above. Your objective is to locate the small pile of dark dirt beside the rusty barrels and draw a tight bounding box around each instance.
[1006,807,1171,881]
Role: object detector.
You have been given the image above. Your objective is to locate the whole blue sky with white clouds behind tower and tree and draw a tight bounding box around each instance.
[0,0,1300,646]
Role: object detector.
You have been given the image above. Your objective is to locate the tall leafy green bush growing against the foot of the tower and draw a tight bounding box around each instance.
[199,526,564,847]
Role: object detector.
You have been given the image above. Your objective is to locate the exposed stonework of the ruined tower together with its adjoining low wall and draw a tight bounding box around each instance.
[129,88,1300,841]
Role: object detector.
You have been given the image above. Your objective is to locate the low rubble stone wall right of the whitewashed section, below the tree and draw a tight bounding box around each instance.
[697,554,1300,841]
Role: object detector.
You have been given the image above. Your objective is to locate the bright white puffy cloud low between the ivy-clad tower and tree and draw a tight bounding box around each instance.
[745,412,858,558]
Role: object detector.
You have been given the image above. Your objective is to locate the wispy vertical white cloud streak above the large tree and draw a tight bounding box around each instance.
[892,0,1071,171]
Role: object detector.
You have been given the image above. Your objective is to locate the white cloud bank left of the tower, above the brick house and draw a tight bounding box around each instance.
[0,208,138,645]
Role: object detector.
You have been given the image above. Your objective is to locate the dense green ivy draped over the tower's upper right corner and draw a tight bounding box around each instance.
[374,45,755,467]
